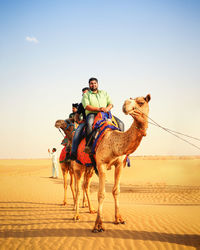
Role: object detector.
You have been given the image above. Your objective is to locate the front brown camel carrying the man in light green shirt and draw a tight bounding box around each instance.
[73,95,151,232]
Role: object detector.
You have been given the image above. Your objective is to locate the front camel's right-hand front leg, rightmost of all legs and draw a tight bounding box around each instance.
[112,165,125,224]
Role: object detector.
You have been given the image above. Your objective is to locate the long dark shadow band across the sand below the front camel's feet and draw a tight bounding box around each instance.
[0,228,200,247]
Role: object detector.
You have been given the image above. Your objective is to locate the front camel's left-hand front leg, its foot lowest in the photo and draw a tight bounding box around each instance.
[92,165,106,233]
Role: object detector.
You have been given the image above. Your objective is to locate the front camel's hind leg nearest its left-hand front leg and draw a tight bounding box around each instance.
[83,167,96,214]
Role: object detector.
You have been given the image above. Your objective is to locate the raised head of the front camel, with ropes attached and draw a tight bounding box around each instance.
[123,94,151,122]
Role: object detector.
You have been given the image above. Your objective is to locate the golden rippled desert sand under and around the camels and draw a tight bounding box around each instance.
[0,156,200,250]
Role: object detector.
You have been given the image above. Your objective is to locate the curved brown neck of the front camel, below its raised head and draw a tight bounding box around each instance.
[117,117,148,155]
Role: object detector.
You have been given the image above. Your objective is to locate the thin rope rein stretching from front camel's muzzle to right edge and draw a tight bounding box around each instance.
[136,108,200,150]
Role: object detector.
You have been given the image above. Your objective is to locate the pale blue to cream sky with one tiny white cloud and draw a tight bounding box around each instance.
[0,0,200,158]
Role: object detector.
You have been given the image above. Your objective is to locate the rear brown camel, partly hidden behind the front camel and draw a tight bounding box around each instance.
[55,119,91,209]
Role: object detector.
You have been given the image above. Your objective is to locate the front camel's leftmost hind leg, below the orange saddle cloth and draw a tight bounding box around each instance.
[73,162,85,220]
